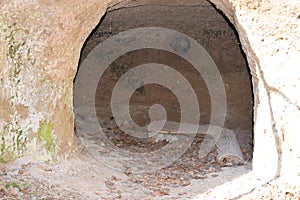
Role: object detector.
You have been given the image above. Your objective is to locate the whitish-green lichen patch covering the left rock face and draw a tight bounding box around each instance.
[0,14,62,162]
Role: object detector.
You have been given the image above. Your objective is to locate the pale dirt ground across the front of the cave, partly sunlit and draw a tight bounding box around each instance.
[0,154,300,200]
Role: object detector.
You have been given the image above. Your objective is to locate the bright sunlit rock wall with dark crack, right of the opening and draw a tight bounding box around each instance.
[212,0,300,178]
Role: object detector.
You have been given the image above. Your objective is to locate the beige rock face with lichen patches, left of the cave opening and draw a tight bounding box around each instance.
[0,1,110,161]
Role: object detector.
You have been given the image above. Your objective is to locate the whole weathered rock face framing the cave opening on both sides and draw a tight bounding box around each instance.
[0,0,300,180]
